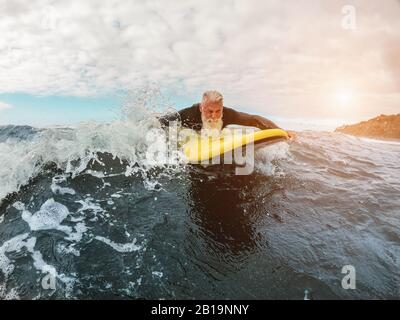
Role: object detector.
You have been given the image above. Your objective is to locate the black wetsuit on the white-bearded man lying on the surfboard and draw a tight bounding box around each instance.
[159,103,279,130]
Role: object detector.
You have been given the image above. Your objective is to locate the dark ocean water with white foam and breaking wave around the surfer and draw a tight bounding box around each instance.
[0,112,400,299]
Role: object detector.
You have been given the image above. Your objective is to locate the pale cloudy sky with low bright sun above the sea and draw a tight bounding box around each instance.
[0,0,400,126]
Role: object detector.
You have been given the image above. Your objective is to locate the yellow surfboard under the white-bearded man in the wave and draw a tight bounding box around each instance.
[183,129,288,163]
